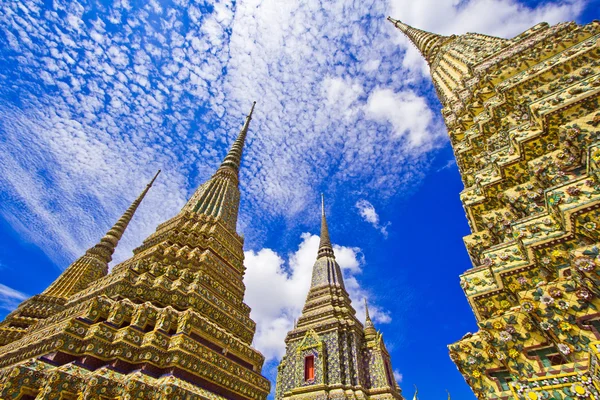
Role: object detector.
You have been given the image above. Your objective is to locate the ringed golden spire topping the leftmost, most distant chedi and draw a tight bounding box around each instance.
[43,170,160,298]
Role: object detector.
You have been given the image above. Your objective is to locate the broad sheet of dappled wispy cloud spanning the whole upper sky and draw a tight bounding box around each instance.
[0,0,583,267]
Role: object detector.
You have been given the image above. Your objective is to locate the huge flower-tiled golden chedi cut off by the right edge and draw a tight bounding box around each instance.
[390,18,600,400]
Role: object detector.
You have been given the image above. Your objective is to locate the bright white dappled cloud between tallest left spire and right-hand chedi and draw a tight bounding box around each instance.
[220,0,450,223]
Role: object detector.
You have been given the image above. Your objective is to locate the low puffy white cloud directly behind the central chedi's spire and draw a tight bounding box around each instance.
[244,233,391,361]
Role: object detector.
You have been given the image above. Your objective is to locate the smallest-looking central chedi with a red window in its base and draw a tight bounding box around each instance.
[275,197,403,400]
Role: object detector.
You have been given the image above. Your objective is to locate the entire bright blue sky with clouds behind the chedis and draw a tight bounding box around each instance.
[0,0,599,399]
